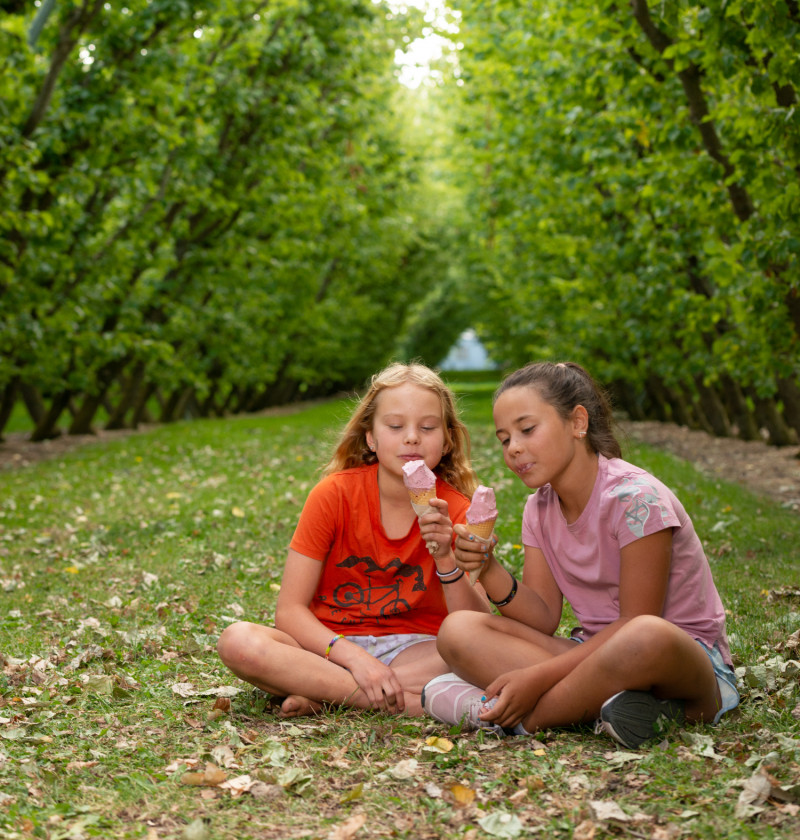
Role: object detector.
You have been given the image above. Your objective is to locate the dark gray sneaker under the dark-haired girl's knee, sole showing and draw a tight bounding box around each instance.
[594,691,685,750]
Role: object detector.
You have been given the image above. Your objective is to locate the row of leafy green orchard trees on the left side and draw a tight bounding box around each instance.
[0,0,465,440]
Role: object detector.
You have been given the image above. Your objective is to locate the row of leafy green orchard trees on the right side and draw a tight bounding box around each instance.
[446,0,800,444]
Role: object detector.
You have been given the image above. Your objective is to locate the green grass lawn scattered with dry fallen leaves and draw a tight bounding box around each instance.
[0,385,800,840]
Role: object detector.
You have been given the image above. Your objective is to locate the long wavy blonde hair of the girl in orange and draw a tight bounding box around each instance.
[323,362,478,499]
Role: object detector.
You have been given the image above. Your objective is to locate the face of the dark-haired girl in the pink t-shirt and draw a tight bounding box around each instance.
[494,386,587,491]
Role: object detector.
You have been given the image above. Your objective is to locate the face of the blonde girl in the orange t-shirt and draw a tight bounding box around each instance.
[367,382,445,476]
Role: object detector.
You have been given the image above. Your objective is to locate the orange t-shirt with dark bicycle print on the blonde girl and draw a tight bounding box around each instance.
[290,464,469,636]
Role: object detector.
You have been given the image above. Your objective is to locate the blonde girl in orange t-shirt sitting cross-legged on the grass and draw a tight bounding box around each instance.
[217,363,489,717]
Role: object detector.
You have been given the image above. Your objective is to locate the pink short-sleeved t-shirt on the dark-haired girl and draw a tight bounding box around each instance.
[522,455,731,665]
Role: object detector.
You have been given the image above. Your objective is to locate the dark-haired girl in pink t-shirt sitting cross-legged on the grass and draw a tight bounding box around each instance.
[423,363,739,749]
